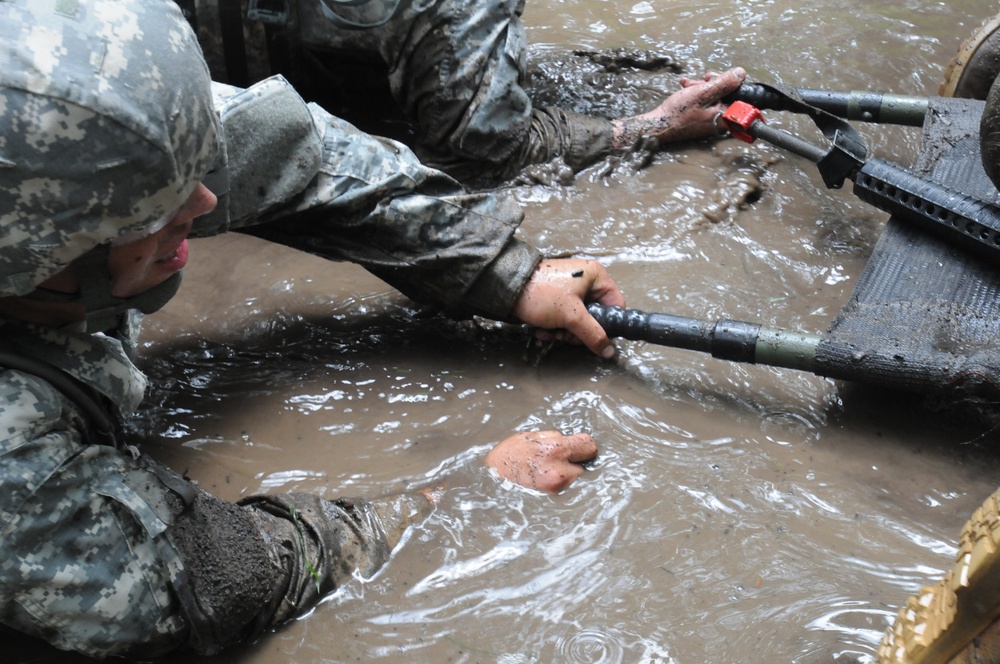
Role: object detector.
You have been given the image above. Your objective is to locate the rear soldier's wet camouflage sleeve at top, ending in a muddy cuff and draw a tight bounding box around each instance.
[297,0,613,181]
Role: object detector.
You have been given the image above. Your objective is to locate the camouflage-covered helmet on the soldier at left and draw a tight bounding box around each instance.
[0,0,220,296]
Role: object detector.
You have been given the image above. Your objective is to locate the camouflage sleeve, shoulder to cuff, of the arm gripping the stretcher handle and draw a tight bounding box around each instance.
[206,78,541,320]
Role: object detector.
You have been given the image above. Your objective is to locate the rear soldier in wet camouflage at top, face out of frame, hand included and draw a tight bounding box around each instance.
[177,0,745,180]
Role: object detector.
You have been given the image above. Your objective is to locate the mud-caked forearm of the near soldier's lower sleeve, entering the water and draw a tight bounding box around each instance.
[167,472,430,654]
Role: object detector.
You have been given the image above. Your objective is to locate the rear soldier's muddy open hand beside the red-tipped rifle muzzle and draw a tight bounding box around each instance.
[612,67,746,148]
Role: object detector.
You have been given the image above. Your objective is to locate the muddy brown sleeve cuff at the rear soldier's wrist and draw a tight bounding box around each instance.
[523,106,614,170]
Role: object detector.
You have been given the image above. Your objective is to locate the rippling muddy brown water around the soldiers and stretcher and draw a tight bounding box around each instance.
[15,0,1000,664]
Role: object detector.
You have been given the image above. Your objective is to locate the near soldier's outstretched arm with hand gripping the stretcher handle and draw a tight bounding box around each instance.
[211,82,625,357]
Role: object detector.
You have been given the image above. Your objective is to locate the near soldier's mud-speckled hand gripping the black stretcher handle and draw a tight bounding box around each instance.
[512,258,625,359]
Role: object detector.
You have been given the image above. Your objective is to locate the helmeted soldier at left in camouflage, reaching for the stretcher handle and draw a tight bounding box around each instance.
[0,0,624,659]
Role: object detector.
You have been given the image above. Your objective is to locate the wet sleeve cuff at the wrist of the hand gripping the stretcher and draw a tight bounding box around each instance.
[462,238,542,321]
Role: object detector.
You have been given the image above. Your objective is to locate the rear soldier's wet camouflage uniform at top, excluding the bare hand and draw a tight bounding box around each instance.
[184,0,612,180]
